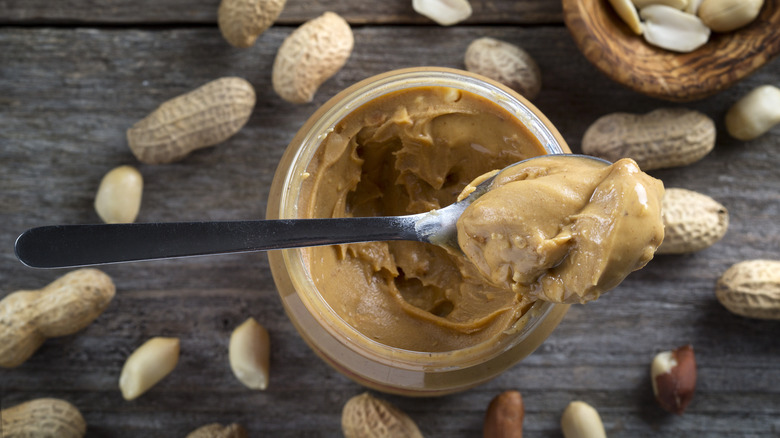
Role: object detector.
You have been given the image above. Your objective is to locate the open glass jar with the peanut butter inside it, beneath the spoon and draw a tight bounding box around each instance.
[267,68,570,396]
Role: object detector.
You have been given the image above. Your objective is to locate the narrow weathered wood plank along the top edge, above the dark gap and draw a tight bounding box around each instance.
[0,0,563,25]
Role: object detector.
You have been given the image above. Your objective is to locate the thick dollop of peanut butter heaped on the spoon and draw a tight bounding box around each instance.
[457,156,664,303]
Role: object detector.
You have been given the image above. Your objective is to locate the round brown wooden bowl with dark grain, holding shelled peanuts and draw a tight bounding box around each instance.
[563,0,780,102]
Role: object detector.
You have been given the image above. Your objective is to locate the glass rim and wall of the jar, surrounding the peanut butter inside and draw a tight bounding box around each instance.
[266,67,571,396]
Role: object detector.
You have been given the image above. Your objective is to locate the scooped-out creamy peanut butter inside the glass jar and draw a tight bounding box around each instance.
[298,87,660,352]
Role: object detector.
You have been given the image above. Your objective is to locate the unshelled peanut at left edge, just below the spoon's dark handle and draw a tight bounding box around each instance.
[0,269,116,368]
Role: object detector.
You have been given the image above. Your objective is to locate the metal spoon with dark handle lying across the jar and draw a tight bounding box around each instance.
[15,154,611,268]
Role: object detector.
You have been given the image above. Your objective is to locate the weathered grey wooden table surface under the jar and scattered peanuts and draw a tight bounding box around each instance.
[0,0,780,437]
